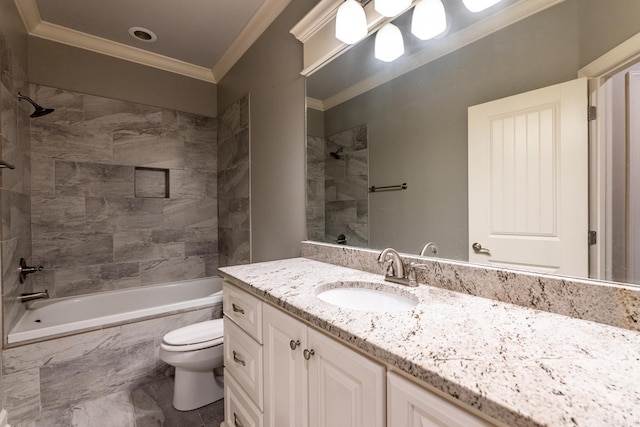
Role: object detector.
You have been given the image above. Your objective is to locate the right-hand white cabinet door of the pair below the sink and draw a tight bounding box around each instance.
[307,328,385,427]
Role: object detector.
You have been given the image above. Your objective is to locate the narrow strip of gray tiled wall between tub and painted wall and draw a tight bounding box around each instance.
[218,95,251,267]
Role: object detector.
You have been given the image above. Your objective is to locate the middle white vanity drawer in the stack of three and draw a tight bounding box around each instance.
[224,315,264,410]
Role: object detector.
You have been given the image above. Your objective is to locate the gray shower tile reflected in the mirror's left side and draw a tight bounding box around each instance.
[307,125,369,247]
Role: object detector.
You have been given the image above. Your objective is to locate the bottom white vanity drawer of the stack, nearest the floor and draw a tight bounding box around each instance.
[224,369,262,427]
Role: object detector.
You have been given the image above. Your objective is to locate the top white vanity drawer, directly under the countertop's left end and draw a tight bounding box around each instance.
[222,282,262,344]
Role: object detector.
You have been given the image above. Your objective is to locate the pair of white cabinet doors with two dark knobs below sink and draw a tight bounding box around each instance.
[263,304,385,427]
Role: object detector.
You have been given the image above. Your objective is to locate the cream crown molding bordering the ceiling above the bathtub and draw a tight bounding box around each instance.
[14,0,291,83]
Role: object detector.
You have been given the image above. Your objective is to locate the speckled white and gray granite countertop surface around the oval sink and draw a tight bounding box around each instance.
[219,258,640,427]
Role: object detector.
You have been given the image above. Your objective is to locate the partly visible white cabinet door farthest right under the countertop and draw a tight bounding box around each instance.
[387,372,493,427]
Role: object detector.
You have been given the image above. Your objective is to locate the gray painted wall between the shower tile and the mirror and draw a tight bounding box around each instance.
[218,0,316,262]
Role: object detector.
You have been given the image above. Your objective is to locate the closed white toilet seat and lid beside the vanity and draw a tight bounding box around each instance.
[161,319,224,351]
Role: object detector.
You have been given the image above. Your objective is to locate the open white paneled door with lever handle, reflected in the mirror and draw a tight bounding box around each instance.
[469,79,589,277]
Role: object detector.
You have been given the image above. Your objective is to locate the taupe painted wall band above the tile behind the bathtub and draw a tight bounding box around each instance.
[29,37,217,117]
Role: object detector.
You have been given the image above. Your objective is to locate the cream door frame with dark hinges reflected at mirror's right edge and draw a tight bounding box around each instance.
[578,33,640,280]
